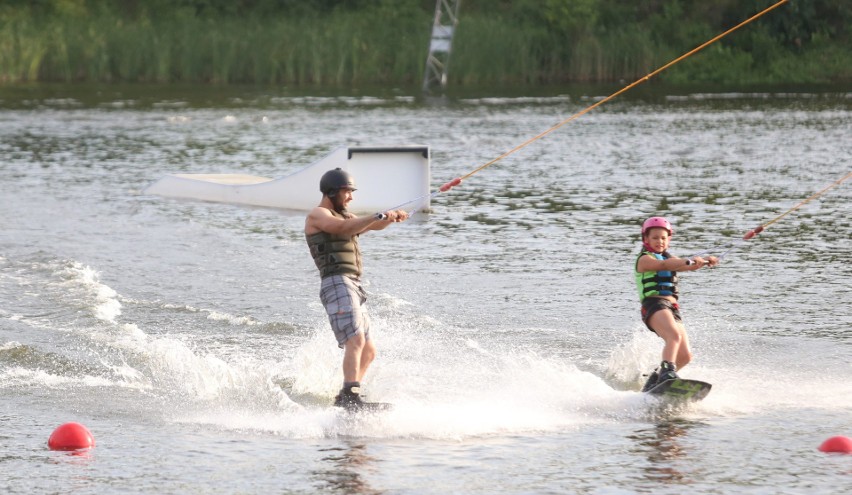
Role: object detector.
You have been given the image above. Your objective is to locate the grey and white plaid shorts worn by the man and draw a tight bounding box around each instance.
[320,275,370,349]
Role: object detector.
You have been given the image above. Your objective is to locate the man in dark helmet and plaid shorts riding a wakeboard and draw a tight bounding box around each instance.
[305,168,408,409]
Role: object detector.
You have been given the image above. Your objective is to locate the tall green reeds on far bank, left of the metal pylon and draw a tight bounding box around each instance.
[0,9,429,85]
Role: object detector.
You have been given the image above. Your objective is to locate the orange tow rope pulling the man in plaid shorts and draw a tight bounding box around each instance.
[390,0,789,214]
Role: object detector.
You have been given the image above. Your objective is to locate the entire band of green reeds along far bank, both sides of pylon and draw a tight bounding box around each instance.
[0,9,852,87]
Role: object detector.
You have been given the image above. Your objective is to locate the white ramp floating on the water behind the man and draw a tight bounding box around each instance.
[143,145,431,213]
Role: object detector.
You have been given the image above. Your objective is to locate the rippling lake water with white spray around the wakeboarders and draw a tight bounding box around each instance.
[0,84,852,494]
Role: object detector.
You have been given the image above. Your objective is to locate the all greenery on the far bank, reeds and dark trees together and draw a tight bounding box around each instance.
[0,0,852,88]
